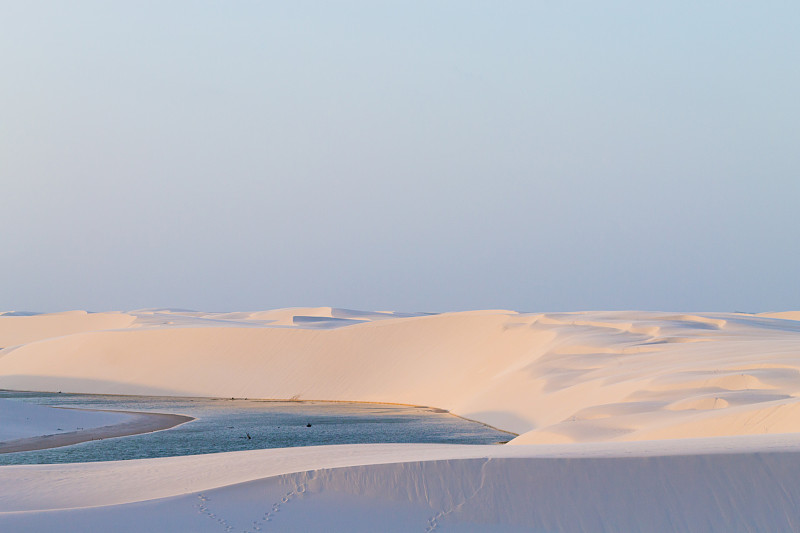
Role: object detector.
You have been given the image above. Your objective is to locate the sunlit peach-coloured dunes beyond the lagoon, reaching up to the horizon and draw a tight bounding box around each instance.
[0,307,800,444]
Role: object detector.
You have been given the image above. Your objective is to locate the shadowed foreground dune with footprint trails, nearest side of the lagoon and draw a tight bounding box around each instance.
[0,436,800,532]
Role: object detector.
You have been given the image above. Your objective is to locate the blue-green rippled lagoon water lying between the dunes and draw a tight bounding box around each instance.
[0,391,511,465]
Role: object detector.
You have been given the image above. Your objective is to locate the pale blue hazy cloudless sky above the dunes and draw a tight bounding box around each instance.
[0,0,800,312]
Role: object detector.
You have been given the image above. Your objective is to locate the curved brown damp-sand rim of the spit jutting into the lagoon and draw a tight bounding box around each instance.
[0,407,194,453]
